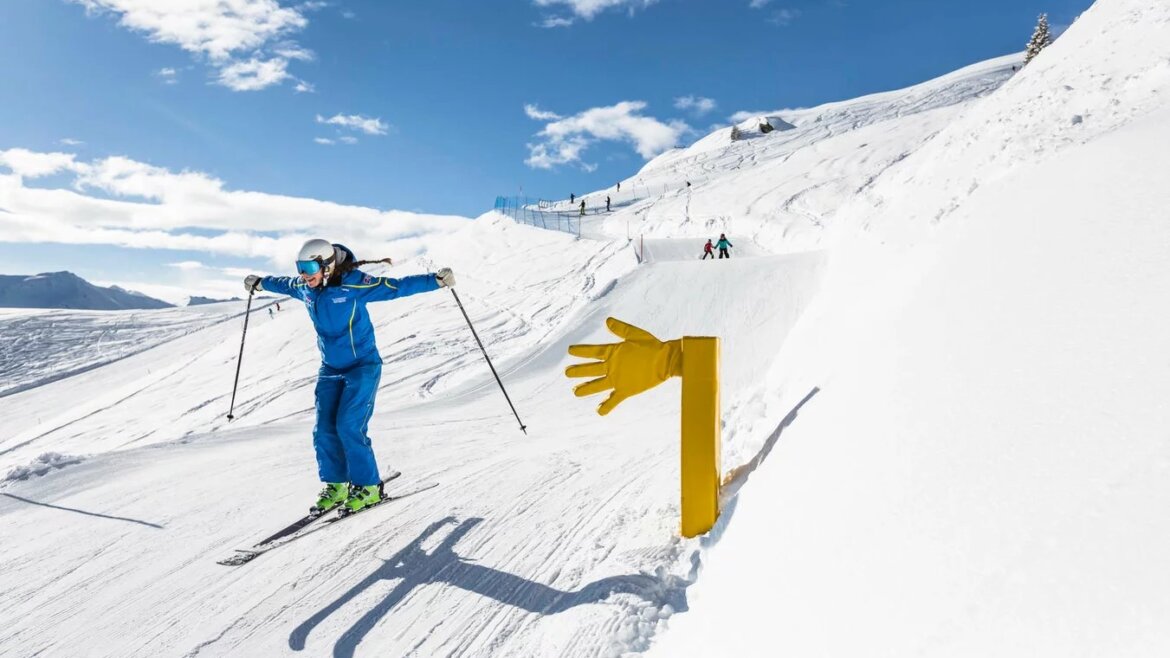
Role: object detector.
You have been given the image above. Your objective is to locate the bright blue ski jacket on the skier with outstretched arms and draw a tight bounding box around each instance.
[261,247,439,370]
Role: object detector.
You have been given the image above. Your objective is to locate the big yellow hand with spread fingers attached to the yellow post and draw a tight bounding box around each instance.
[565,317,682,416]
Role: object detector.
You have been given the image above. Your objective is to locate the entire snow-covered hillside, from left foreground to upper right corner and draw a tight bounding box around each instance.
[0,0,1170,657]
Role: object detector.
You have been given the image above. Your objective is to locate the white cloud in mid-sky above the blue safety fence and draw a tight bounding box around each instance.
[524,101,691,170]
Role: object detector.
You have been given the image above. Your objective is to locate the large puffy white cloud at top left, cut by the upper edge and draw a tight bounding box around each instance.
[69,0,314,91]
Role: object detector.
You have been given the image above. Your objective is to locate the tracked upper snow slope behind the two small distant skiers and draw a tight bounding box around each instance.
[583,55,1021,253]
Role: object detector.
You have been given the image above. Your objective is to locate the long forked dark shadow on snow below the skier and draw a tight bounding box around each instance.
[289,516,689,657]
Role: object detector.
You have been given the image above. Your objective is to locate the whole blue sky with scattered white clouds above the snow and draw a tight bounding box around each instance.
[0,0,1090,302]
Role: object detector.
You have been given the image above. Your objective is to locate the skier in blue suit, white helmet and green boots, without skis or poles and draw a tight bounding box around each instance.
[245,240,455,512]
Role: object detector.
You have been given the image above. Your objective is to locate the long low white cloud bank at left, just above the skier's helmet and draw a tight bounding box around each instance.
[0,149,466,267]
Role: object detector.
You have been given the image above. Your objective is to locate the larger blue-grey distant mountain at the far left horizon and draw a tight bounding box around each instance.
[0,272,174,310]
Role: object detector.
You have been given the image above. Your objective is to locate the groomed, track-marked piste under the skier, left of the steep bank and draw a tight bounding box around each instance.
[0,215,820,656]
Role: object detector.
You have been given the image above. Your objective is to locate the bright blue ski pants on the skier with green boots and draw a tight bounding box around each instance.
[312,357,381,486]
